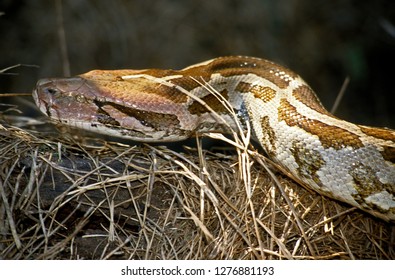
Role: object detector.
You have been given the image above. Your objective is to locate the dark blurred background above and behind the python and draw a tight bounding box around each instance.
[0,0,395,128]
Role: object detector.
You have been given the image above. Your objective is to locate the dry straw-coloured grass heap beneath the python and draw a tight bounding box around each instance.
[0,114,395,259]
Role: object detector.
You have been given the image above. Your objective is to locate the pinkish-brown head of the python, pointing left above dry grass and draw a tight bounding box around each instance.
[33,74,200,142]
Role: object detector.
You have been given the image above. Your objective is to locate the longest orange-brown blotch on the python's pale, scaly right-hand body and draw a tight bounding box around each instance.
[278,98,363,150]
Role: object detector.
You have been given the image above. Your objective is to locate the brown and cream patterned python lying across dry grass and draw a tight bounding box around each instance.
[33,56,395,221]
